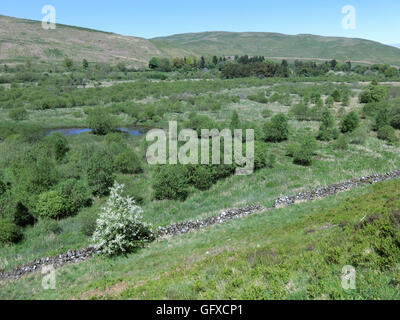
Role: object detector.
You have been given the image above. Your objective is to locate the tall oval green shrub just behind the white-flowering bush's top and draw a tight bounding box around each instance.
[86,150,114,196]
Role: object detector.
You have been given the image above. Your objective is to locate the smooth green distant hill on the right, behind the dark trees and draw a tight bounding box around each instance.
[151,32,400,65]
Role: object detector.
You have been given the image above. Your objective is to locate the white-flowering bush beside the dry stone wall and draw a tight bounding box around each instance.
[93,182,154,256]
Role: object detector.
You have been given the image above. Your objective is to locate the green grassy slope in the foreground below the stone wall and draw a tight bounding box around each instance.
[0,180,400,299]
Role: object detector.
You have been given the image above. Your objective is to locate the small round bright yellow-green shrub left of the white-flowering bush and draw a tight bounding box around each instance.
[36,190,67,219]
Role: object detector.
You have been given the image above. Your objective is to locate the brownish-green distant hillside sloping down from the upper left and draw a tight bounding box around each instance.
[0,15,161,66]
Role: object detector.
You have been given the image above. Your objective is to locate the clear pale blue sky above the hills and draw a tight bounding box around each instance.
[0,0,400,44]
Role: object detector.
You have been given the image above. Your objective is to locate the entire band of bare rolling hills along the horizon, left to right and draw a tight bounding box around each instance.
[0,15,400,66]
